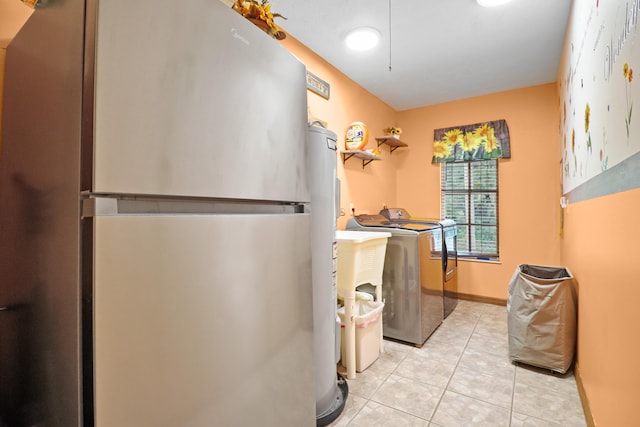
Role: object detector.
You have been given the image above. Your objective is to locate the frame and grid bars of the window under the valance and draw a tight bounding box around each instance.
[440,159,500,261]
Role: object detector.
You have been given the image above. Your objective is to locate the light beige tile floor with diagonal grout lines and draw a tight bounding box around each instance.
[331,300,586,427]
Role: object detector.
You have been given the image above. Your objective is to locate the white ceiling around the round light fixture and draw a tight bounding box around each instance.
[270,0,571,111]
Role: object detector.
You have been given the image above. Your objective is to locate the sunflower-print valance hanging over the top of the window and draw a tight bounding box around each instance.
[431,120,511,163]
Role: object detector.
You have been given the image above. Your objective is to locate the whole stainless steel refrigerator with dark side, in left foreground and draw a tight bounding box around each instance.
[0,0,315,427]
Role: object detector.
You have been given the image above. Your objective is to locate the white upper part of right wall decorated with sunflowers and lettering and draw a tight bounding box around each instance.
[558,0,640,194]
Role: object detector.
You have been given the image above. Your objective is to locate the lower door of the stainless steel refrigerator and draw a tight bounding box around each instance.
[93,214,315,427]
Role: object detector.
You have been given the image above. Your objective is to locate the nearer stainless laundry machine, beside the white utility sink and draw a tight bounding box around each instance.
[346,214,444,347]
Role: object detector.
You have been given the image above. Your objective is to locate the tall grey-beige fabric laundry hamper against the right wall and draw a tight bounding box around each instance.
[507,264,577,374]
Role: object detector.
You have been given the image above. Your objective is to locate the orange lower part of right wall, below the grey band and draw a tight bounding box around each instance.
[562,189,640,427]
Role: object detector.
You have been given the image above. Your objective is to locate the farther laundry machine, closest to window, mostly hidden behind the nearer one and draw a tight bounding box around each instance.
[380,208,458,319]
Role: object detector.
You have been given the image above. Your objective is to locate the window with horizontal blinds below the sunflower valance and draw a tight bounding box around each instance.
[440,160,498,257]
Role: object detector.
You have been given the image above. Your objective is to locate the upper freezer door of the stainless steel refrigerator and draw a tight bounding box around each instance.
[89,0,309,202]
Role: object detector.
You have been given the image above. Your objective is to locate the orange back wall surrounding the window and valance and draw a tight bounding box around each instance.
[394,84,560,300]
